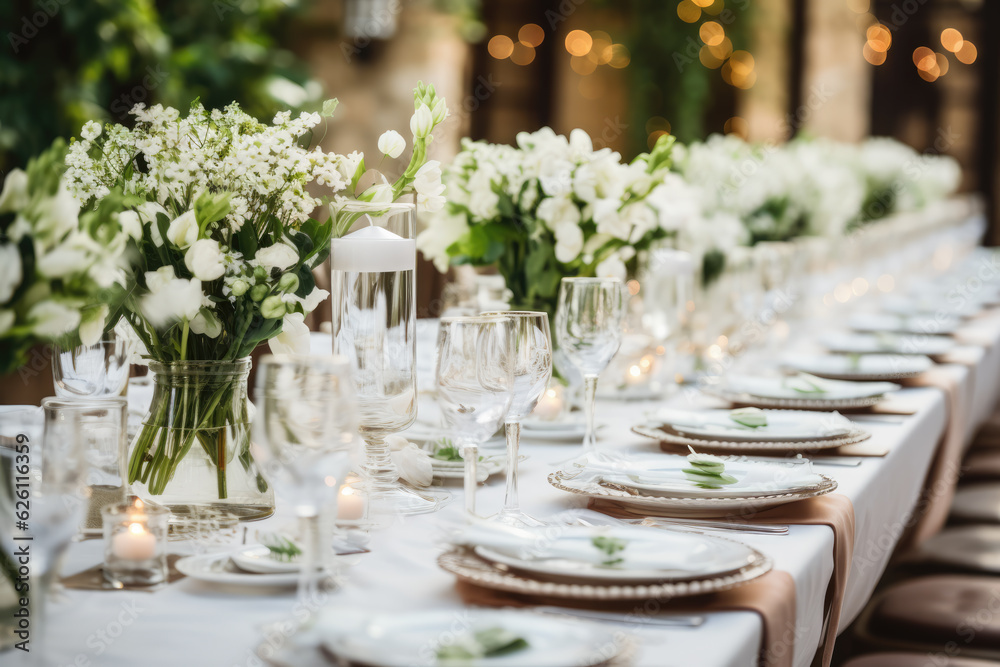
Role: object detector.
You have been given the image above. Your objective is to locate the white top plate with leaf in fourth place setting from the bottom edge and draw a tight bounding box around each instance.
[655,408,854,440]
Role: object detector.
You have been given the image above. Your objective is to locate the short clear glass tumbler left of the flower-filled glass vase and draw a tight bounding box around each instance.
[52,332,130,398]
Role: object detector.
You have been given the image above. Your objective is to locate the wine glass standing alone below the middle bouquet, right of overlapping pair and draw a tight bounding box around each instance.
[556,278,625,450]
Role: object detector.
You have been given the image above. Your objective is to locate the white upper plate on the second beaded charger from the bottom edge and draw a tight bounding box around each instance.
[473,526,756,584]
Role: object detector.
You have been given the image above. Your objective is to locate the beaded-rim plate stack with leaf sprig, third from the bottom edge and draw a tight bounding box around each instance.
[549,455,837,517]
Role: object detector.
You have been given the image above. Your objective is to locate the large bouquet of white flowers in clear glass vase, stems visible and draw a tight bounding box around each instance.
[66,84,447,518]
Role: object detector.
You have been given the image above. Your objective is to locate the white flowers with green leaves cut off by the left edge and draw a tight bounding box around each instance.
[0,141,129,373]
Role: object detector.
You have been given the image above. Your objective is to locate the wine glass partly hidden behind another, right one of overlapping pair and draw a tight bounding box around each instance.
[483,311,552,527]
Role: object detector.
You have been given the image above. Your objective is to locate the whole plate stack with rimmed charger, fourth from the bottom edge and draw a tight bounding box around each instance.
[632,410,871,453]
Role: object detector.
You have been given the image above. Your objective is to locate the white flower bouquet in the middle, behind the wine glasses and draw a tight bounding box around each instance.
[417,128,700,313]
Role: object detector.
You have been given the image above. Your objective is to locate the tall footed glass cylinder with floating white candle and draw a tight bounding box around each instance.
[330,201,450,514]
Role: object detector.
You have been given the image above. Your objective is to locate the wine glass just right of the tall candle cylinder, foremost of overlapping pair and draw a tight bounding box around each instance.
[437,316,514,514]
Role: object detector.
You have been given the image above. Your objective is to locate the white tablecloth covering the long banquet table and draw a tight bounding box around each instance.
[47,262,1000,667]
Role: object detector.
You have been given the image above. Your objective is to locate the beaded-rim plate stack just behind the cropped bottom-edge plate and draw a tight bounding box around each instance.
[438,525,771,600]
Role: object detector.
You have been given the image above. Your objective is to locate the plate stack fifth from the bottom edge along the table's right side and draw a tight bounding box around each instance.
[701,374,901,411]
